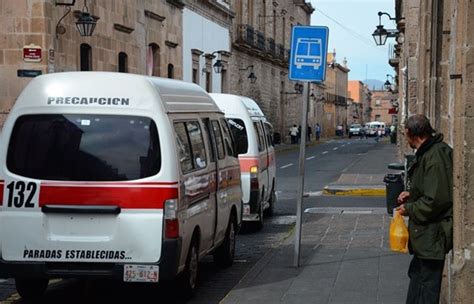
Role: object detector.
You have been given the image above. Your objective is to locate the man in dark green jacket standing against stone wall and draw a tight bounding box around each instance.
[398,115,453,304]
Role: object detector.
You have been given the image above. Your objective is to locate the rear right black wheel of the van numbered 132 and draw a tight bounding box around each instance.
[179,237,199,299]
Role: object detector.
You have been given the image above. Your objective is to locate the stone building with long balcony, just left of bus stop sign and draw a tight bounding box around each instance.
[229,0,314,140]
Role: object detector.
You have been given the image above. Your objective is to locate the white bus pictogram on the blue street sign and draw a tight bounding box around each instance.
[294,38,322,70]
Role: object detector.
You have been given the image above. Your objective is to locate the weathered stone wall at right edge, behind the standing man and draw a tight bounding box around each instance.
[391,0,474,303]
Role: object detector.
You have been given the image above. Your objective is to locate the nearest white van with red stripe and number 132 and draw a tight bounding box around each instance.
[0,72,242,298]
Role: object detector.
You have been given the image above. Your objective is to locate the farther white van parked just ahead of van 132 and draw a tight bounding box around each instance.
[210,94,276,226]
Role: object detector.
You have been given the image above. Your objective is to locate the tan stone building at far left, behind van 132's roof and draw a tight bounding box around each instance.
[0,0,184,126]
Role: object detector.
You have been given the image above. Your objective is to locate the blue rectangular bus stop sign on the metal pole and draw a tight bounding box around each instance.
[289,26,329,82]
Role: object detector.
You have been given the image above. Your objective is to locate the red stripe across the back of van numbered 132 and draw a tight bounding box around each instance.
[39,183,178,209]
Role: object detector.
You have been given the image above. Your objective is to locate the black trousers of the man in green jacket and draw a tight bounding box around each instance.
[407,256,444,304]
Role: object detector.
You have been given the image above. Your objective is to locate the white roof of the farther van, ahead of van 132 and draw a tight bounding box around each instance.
[209,93,265,118]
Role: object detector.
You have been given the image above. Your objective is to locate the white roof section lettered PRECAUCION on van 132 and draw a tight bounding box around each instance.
[12,72,221,112]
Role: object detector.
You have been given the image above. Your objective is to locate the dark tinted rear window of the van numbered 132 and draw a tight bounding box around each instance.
[7,114,161,181]
